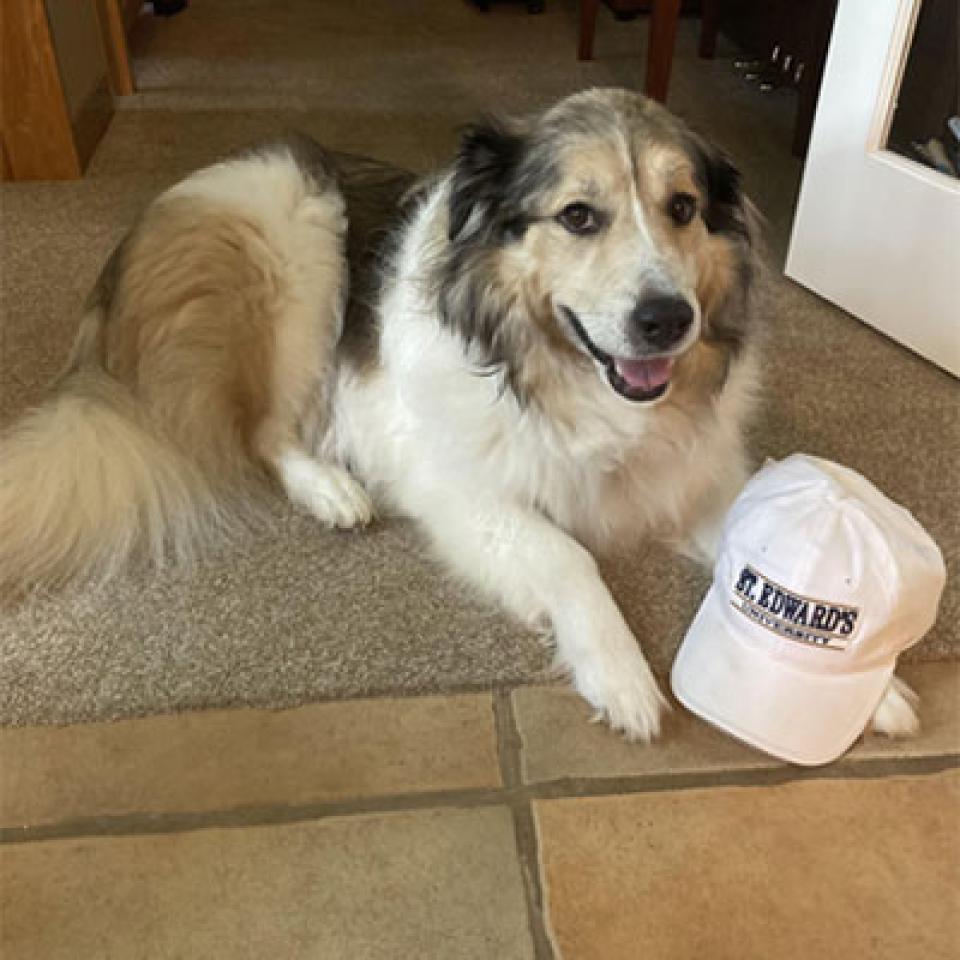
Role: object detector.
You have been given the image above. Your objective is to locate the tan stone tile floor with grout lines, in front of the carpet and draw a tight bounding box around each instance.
[0,664,960,960]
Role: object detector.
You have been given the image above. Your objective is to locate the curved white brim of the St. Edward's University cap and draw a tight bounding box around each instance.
[670,587,894,766]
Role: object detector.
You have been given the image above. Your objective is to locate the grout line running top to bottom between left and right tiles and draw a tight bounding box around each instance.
[493,688,555,960]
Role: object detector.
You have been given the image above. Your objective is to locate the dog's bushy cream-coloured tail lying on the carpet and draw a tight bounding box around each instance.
[0,308,229,602]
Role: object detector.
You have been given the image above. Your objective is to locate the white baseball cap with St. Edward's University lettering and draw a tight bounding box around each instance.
[671,454,946,766]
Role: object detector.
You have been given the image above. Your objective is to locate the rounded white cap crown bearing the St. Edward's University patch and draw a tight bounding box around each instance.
[714,454,946,673]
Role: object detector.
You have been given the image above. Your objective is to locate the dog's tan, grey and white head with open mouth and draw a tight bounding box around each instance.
[441,90,754,402]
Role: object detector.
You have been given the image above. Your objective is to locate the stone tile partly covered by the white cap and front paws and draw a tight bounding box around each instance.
[513,663,960,783]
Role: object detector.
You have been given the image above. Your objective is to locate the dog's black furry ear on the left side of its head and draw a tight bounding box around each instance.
[449,119,523,242]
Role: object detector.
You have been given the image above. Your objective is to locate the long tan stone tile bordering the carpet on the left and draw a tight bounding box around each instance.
[0,694,501,826]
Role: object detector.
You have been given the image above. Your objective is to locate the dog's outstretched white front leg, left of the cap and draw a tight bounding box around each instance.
[418,497,666,740]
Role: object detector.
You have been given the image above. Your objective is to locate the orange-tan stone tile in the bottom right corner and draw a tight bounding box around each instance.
[534,771,960,960]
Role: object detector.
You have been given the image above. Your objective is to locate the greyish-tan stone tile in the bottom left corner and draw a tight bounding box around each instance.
[0,808,533,960]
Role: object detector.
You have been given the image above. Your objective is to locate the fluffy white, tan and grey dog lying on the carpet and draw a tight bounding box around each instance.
[0,89,916,740]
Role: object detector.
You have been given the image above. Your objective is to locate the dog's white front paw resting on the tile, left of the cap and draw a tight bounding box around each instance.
[573,650,669,743]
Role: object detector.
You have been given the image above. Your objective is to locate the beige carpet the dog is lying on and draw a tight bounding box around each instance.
[0,0,960,724]
